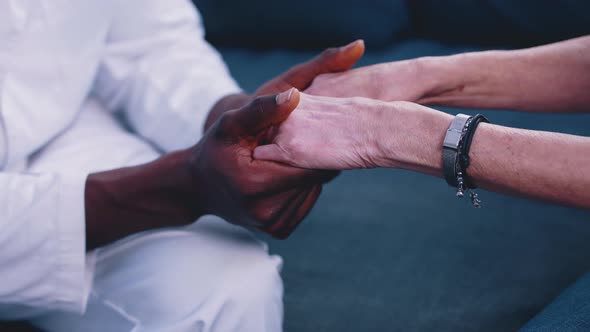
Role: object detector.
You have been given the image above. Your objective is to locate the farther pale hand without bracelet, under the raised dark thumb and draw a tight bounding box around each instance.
[304,59,442,103]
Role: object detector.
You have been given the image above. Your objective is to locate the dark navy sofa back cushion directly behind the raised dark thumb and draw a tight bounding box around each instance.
[195,0,408,48]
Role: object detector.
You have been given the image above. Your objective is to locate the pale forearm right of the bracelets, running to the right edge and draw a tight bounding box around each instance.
[468,124,590,208]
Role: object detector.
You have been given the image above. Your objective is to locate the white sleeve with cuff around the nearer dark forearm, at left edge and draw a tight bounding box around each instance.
[0,171,94,319]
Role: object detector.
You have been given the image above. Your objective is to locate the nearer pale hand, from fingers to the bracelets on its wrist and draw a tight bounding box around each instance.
[254,94,450,174]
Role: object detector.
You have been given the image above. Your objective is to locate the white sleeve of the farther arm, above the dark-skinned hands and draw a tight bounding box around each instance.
[94,0,240,151]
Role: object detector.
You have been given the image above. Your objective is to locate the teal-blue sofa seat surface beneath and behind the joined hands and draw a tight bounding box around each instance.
[222,40,590,332]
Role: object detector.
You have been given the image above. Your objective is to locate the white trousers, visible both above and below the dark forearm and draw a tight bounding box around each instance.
[23,101,283,332]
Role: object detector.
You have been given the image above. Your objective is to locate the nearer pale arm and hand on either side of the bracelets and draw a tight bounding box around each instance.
[254,95,590,209]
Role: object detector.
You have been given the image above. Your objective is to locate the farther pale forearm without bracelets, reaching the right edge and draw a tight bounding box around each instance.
[416,36,590,112]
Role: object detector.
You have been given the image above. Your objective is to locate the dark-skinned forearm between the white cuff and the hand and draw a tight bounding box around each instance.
[85,151,202,248]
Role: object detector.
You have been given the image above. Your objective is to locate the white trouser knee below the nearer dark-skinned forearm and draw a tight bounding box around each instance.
[32,216,283,332]
